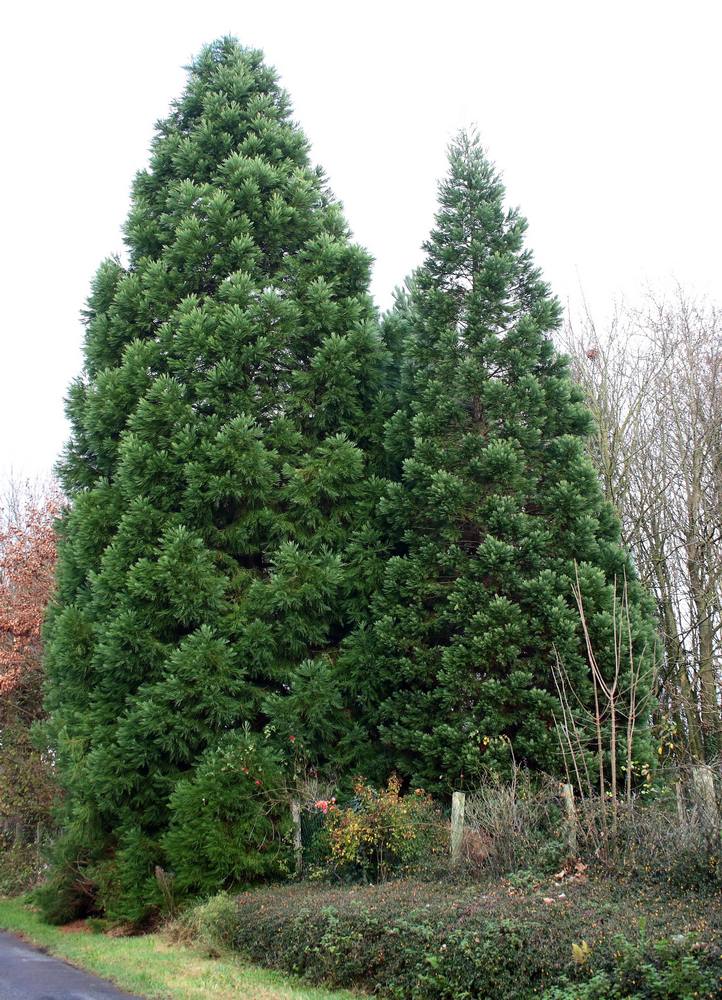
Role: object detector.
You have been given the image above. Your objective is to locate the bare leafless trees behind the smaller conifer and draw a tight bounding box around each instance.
[563,289,722,760]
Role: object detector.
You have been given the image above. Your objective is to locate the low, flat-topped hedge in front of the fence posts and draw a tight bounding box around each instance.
[183,882,722,1000]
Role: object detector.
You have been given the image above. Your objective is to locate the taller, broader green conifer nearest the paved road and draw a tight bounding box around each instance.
[41,39,383,918]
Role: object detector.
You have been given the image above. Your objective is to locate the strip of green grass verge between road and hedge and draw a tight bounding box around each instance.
[0,899,358,1000]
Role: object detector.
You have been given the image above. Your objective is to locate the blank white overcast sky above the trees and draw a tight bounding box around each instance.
[0,0,722,479]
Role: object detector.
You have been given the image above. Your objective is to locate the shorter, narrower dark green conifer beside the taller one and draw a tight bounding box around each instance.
[341,135,653,790]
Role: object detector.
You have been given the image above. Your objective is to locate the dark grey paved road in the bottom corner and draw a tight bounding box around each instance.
[0,931,140,1000]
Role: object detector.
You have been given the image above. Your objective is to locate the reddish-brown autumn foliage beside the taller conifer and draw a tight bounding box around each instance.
[0,486,61,837]
